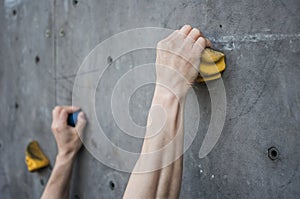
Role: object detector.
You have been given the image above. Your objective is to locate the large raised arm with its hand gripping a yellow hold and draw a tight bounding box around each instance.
[124,25,210,198]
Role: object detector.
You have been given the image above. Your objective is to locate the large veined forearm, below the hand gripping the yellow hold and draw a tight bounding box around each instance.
[124,86,184,198]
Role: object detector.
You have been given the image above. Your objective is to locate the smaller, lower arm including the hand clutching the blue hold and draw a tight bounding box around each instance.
[41,106,86,199]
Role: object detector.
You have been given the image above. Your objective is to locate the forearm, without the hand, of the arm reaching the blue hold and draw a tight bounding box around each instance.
[41,155,75,199]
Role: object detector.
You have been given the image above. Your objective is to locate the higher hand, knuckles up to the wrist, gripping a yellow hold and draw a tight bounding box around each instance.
[156,25,211,97]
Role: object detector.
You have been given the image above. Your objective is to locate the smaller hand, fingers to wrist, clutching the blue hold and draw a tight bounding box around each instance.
[51,106,86,159]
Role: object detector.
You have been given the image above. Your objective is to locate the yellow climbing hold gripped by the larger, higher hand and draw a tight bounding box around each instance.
[196,48,226,82]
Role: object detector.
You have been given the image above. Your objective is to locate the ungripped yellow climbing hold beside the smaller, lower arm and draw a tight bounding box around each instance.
[25,141,50,172]
